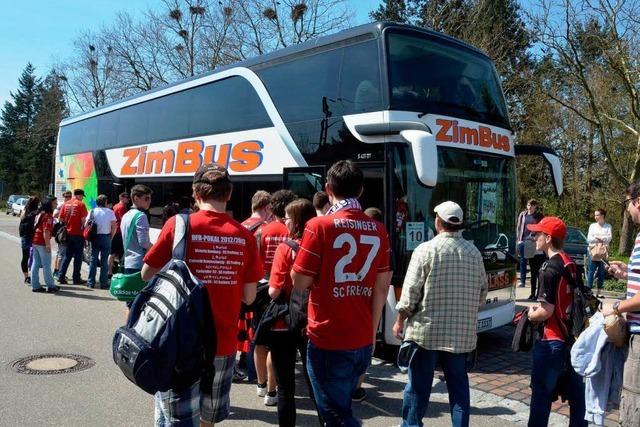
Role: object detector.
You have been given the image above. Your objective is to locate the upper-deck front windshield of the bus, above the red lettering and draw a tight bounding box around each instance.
[387,32,510,129]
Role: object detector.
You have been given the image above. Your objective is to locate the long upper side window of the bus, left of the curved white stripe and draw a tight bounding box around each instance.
[59,77,272,155]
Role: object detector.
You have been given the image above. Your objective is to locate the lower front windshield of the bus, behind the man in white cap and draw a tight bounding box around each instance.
[393,144,516,272]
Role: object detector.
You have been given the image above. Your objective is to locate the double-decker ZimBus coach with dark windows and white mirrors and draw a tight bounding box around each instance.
[55,23,562,352]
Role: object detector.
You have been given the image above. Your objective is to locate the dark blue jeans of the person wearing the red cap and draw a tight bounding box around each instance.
[529,341,588,427]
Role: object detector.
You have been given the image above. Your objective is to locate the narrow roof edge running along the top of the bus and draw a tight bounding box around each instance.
[60,22,487,126]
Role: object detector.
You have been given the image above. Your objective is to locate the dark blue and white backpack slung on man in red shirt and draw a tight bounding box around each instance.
[113,214,216,394]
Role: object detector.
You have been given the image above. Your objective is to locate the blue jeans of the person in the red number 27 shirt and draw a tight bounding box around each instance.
[307,341,372,427]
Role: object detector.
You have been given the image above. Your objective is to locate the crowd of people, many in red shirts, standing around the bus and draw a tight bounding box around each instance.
[11,161,640,426]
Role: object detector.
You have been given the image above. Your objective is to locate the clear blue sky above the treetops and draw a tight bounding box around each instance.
[0,0,380,108]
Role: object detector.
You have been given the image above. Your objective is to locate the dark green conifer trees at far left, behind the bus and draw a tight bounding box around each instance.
[0,64,66,194]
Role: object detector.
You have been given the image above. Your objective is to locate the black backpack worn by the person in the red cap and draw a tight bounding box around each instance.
[544,253,602,345]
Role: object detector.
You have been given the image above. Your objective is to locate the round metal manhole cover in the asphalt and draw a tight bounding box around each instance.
[11,354,95,375]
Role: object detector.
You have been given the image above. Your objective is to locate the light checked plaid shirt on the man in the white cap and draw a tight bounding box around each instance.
[396,231,487,353]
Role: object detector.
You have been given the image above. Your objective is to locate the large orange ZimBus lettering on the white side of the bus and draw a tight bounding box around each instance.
[120,140,264,175]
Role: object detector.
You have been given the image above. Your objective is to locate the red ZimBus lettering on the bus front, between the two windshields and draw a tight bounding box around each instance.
[436,119,511,153]
